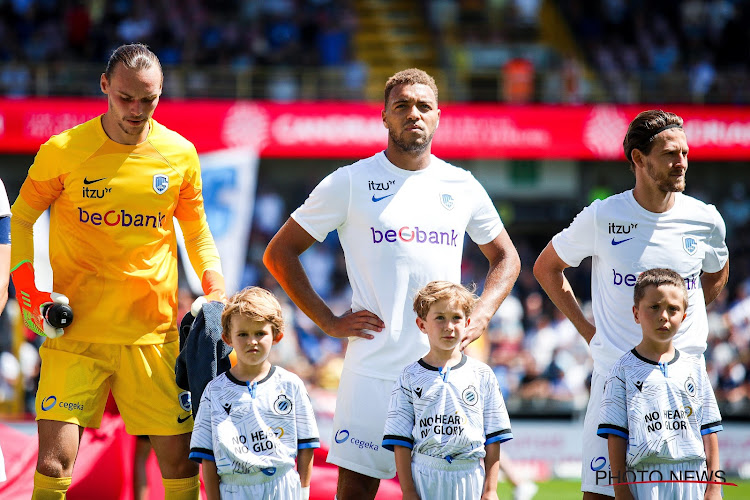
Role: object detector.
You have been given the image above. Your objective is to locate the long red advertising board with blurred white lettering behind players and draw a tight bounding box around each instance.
[0,97,750,160]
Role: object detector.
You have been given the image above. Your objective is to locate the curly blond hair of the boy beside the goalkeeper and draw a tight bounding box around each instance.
[221,286,284,339]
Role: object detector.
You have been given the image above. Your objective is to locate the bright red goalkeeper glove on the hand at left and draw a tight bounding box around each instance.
[10,260,69,339]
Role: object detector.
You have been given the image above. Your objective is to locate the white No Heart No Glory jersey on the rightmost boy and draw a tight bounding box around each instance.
[597,349,722,468]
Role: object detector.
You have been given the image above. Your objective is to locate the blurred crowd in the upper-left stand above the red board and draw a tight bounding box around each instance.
[0,0,356,97]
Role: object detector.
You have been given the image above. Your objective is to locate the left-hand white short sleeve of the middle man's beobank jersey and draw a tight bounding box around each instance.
[292,167,351,241]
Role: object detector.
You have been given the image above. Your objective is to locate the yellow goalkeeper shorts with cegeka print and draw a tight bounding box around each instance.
[36,336,193,436]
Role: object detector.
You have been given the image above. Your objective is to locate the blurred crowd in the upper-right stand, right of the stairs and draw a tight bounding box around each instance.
[561,0,750,104]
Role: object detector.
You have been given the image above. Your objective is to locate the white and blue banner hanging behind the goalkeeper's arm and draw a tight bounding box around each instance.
[175,149,258,295]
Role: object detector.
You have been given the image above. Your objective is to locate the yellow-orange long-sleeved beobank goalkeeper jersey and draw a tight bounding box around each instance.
[13,117,218,344]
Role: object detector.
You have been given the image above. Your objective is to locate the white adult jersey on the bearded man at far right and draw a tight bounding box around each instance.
[552,191,729,375]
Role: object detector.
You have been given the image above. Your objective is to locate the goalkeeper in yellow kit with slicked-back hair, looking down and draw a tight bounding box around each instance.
[11,44,224,500]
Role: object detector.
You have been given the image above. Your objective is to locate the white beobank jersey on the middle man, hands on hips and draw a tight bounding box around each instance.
[292,152,503,380]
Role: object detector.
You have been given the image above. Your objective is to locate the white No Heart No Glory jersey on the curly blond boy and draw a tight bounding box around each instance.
[190,366,320,476]
